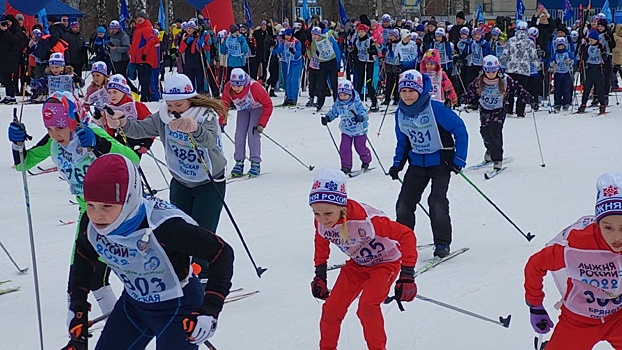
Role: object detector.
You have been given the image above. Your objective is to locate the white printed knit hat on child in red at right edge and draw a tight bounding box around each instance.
[595,173,622,221]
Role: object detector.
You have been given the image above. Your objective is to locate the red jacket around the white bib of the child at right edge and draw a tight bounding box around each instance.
[525,222,612,323]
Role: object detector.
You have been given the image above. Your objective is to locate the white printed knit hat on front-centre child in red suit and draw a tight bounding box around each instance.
[309,169,348,207]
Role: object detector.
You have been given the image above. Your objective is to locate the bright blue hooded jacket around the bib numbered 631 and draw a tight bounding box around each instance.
[393,74,469,167]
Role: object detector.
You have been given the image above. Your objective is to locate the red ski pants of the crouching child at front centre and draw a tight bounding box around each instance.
[320,260,400,350]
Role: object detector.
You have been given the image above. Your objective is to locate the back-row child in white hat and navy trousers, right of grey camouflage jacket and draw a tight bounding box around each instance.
[551,37,574,113]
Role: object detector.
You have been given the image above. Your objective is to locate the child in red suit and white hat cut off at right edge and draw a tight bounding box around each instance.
[525,174,622,350]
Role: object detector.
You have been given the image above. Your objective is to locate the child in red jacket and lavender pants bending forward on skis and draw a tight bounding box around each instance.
[220,68,273,177]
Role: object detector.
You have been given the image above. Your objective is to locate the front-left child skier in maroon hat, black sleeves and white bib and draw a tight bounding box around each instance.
[64,154,233,350]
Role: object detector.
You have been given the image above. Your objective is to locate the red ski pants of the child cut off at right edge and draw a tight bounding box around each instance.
[546,308,622,350]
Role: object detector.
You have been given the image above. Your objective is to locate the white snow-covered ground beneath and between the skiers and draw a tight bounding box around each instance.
[0,78,622,350]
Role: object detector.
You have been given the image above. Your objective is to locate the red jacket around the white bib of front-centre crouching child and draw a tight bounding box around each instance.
[313,199,417,266]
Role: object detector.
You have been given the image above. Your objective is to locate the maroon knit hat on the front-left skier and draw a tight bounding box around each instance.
[84,154,130,204]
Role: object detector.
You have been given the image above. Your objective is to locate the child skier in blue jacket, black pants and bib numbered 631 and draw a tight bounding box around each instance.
[389,69,469,258]
